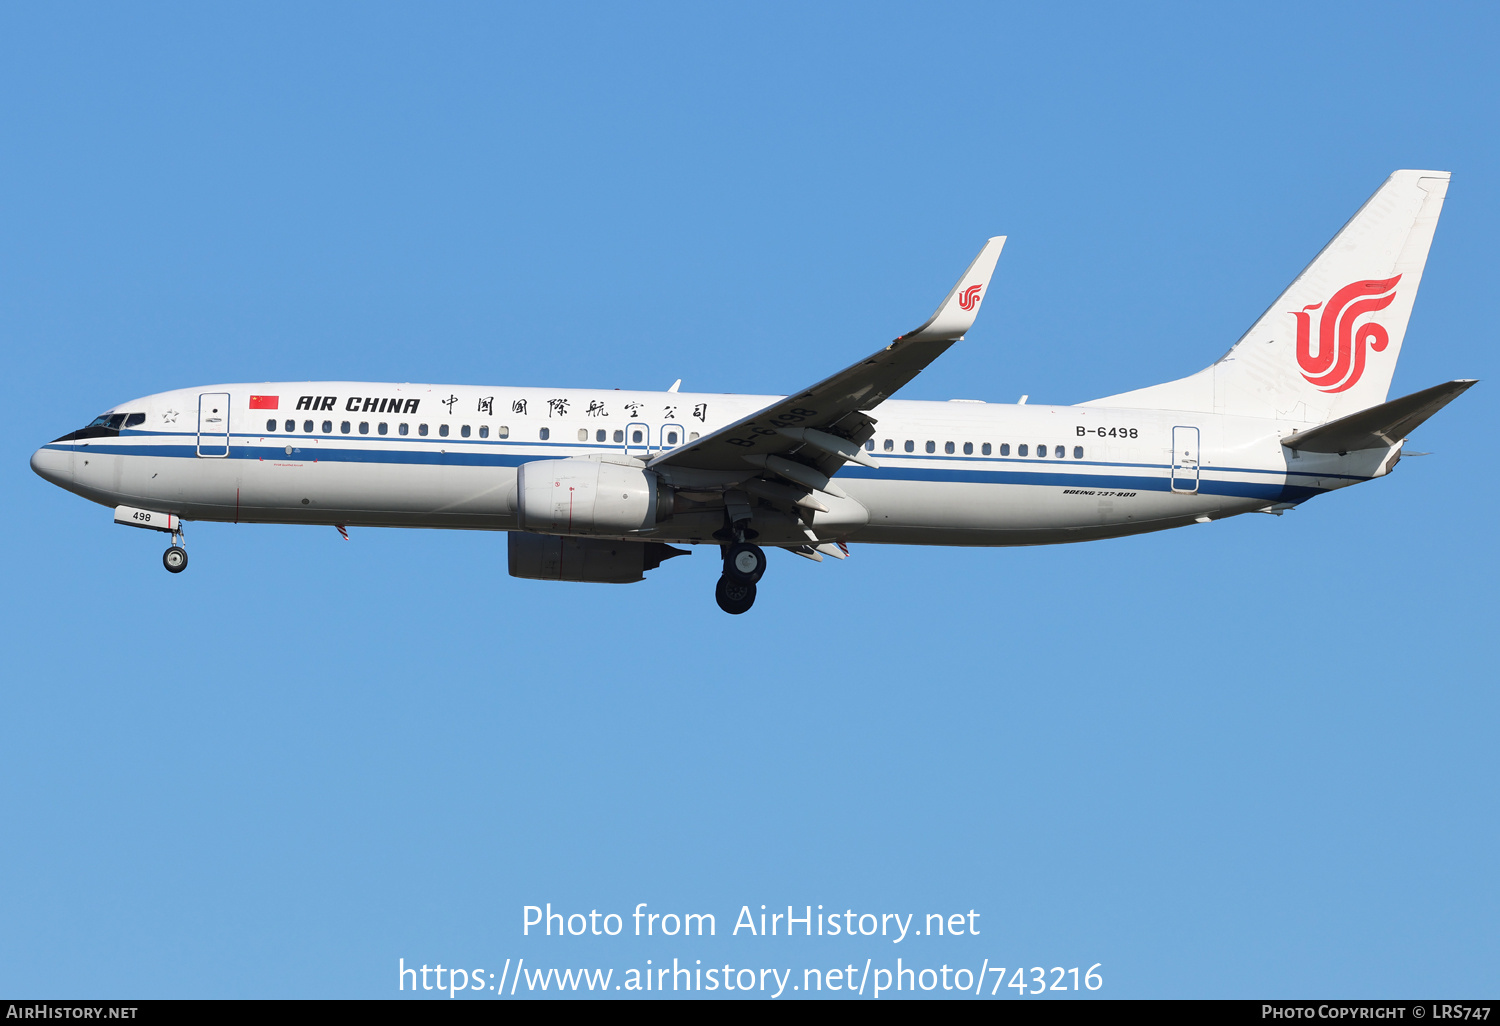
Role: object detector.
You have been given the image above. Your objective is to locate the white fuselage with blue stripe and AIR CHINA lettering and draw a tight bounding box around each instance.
[33,381,1400,546]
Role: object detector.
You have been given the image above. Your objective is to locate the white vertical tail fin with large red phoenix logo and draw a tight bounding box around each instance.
[1085,171,1449,423]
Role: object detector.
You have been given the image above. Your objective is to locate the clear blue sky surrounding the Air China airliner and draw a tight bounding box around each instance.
[0,3,1500,998]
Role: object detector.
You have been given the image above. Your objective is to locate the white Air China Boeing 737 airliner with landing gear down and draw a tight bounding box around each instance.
[32,171,1475,614]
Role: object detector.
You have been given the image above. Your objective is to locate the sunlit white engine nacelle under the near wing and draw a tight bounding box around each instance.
[516,458,672,534]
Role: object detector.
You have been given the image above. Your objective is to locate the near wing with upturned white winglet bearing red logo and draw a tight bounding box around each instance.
[648,236,1005,492]
